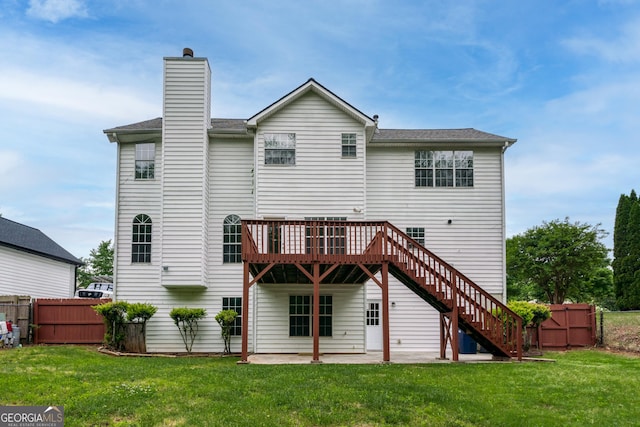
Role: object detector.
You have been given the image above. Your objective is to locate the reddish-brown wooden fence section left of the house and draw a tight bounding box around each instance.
[33,298,110,344]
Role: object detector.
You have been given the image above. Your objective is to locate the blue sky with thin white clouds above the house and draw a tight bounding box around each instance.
[0,0,640,257]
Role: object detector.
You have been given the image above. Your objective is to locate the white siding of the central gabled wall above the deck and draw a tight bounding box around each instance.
[256,93,365,220]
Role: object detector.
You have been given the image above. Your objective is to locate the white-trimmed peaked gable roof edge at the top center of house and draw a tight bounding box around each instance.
[247,78,376,129]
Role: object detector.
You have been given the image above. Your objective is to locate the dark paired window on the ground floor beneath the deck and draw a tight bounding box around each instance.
[289,295,333,337]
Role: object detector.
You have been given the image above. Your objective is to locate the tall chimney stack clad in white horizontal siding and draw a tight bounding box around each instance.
[160,58,211,287]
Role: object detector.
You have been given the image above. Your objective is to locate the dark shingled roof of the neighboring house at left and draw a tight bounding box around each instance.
[0,217,83,265]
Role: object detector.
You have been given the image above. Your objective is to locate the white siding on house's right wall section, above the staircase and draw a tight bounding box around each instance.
[367,147,504,299]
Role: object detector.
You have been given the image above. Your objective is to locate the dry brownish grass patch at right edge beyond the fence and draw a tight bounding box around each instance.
[598,311,640,352]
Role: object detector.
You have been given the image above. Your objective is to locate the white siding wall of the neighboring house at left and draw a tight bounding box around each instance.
[0,246,75,298]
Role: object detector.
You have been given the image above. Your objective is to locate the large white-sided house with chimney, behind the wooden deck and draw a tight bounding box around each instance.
[104,50,515,353]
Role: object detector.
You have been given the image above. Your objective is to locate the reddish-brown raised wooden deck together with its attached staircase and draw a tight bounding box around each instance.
[242,220,522,361]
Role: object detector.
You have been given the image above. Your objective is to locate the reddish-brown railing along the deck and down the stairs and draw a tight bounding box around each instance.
[242,220,522,356]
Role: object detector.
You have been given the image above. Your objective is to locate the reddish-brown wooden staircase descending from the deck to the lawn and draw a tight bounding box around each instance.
[368,223,522,360]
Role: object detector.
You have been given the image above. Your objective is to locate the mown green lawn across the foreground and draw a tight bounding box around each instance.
[0,346,640,426]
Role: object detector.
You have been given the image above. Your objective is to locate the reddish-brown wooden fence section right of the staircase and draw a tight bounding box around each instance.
[532,304,596,351]
